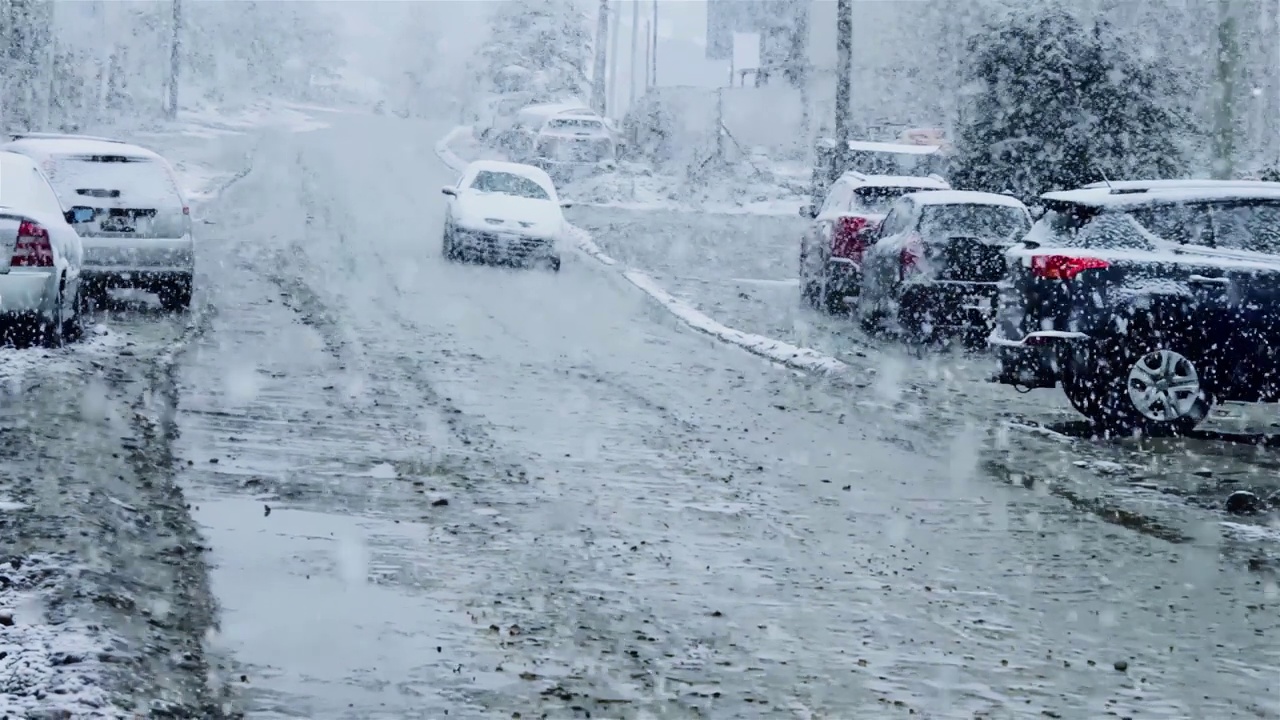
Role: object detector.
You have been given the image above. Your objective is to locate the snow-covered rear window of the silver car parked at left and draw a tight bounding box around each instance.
[47,155,182,206]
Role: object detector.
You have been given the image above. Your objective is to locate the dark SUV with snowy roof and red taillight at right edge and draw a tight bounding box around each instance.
[988,181,1280,434]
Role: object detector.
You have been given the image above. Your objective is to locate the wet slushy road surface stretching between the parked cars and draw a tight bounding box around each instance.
[0,110,1280,719]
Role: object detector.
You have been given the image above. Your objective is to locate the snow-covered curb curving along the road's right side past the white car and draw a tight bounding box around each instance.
[435,126,849,375]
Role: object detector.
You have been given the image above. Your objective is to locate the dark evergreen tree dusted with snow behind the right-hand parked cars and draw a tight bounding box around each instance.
[954,9,1189,201]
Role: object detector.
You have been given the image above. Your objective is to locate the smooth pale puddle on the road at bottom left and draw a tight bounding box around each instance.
[193,497,513,717]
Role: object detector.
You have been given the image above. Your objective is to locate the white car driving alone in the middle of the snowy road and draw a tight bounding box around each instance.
[442,160,570,270]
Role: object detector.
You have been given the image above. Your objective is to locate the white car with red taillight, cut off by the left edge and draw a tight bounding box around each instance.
[0,151,87,347]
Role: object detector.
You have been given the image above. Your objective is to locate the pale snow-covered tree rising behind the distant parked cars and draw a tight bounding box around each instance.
[477,0,591,96]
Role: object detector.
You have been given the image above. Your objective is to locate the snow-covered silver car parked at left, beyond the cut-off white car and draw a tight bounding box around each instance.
[0,133,195,310]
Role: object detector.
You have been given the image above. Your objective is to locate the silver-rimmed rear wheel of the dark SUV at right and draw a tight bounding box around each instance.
[1062,338,1213,437]
